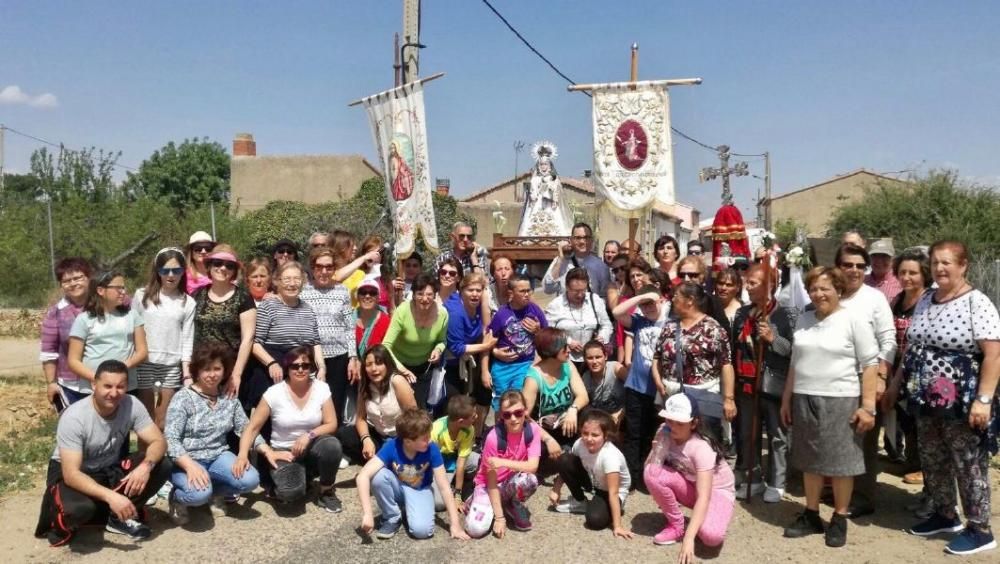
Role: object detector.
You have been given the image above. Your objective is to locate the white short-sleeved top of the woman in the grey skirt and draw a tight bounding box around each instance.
[792,308,879,398]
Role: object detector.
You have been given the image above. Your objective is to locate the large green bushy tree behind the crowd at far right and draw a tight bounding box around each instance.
[828,171,1000,257]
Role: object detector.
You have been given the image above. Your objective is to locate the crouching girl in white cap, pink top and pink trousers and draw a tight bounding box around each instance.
[643,393,736,563]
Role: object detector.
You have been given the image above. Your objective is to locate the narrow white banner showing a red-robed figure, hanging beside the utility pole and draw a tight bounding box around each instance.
[361,82,438,260]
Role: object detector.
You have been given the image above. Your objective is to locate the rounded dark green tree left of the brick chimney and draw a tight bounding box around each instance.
[124,138,229,209]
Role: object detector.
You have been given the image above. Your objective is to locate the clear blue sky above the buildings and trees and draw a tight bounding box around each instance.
[0,0,1000,216]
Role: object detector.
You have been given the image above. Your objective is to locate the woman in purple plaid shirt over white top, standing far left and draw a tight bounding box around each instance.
[39,257,92,413]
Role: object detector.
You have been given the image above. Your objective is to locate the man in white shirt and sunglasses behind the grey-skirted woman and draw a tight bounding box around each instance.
[836,243,896,519]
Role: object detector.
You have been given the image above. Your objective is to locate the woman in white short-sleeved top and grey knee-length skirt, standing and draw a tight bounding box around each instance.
[781,266,879,547]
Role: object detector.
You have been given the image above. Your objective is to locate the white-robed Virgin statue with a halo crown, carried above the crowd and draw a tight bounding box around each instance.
[517,141,573,237]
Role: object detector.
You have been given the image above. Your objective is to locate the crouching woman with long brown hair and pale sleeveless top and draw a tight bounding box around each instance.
[339,345,417,464]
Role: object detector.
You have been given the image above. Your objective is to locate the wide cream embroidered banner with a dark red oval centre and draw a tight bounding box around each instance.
[592,82,674,217]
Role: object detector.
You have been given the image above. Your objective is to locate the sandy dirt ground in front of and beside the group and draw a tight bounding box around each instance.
[0,340,1000,564]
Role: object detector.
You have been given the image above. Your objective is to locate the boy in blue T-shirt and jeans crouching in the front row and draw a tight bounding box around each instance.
[357,408,469,539]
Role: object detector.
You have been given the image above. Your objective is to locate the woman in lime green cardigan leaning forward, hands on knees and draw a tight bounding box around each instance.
[383,274,448,409]
